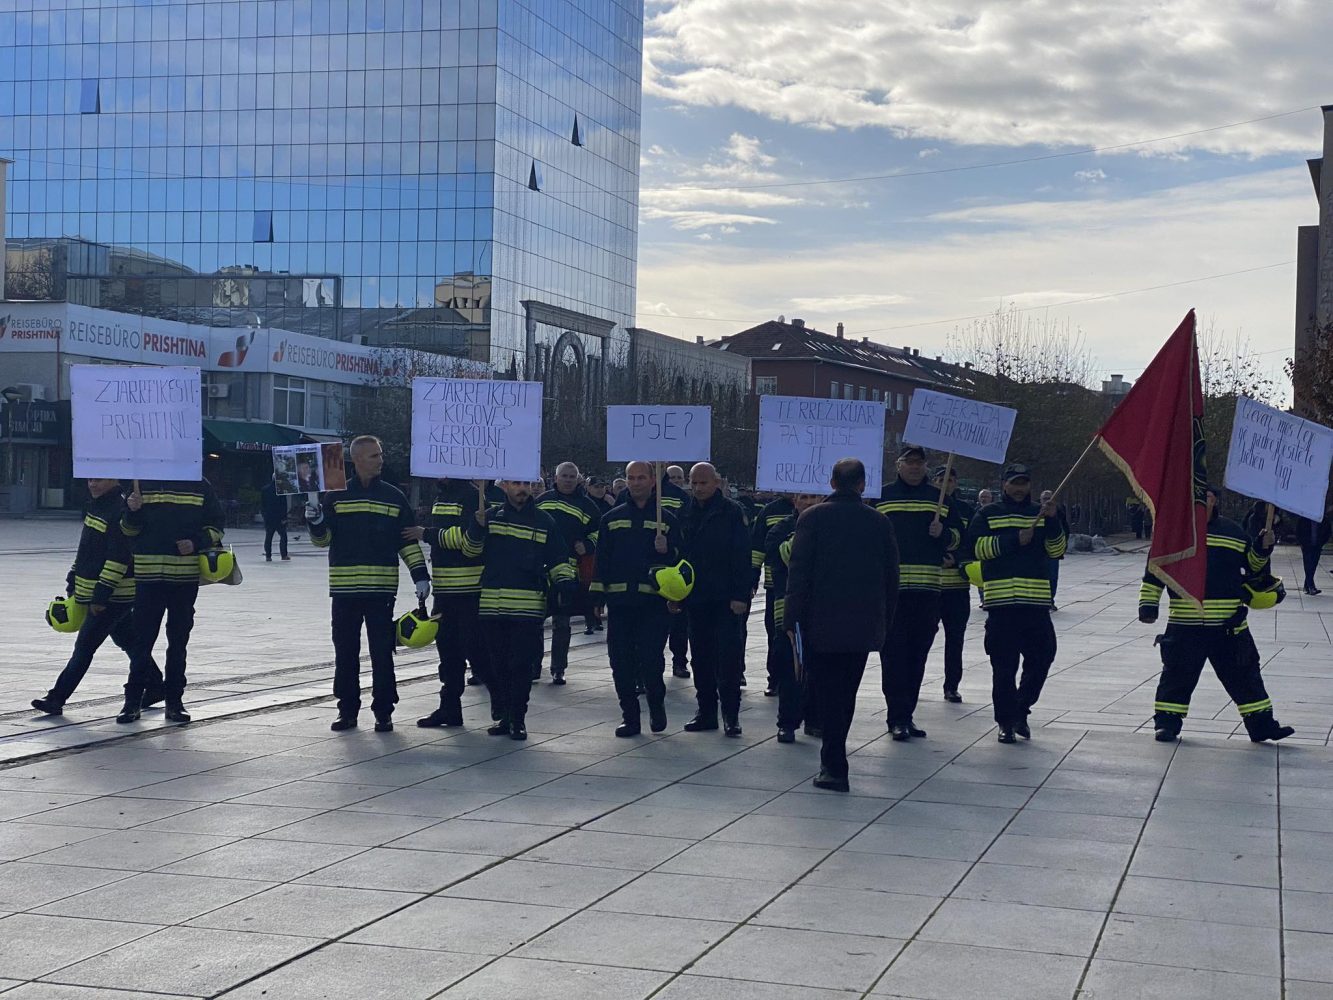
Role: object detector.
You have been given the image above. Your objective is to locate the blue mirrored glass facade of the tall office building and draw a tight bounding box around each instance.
[0,0,643,384]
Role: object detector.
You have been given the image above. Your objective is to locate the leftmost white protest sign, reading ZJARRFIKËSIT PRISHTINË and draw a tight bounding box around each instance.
[69,364,204,481]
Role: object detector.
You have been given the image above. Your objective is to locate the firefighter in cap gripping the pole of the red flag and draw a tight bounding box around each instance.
[968,465,1068,743]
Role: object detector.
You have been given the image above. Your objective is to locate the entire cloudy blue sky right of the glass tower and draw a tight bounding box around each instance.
[639,0,1333,392]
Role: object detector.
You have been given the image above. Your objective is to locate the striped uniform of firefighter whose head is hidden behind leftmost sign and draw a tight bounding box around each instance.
[120,479,224,707]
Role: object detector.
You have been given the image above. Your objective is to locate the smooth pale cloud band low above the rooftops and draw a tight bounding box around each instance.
[639,165,1318,377]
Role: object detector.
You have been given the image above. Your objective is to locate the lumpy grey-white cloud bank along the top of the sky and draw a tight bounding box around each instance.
[644,0,1333,155]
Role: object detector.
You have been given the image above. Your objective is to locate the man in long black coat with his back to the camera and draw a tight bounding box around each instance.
[785,459,898,792]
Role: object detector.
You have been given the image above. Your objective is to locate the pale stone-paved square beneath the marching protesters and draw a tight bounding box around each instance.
[0,521,1333,1000]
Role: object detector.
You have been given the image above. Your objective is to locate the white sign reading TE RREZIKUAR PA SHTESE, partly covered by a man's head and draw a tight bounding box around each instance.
[754,396,884,497]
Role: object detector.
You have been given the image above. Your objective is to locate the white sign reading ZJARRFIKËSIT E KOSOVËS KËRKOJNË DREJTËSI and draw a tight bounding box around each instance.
[412,379,541,480]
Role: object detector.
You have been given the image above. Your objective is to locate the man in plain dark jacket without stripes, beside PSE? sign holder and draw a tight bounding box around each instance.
[681,461,753,736]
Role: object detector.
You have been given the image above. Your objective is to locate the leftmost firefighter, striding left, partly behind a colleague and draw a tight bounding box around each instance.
[32,479,163,715]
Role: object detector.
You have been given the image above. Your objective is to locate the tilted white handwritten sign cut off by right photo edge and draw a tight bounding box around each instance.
[1226,396,1333,521]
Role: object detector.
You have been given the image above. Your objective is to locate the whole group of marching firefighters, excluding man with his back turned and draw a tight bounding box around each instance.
[32,435,1293,784]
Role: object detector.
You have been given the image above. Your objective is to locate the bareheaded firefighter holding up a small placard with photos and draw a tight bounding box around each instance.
[305,435,431,732]
